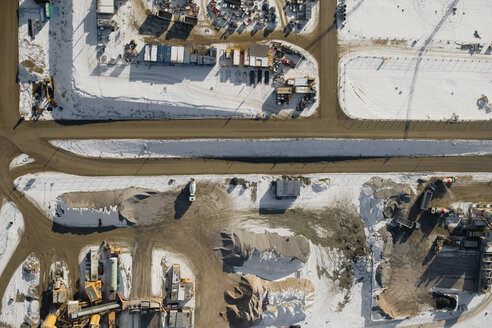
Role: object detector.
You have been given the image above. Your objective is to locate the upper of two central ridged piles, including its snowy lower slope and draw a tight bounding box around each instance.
[219,230,310,280]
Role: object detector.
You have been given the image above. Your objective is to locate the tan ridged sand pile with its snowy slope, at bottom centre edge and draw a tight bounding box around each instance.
[225,275,314,327]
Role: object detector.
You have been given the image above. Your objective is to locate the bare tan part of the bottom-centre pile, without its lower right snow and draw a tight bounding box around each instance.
[223,275,314,327]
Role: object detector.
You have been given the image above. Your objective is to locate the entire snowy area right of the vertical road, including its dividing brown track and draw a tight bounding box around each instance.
[338,0,492,121]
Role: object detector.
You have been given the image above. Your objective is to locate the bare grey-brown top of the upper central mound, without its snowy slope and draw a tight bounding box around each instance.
[220,230,310,266]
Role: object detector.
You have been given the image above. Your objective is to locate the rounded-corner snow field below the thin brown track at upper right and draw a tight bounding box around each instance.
[339,54,492,121]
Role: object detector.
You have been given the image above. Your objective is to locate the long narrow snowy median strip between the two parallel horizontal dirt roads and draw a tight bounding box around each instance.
[50,139,492,158]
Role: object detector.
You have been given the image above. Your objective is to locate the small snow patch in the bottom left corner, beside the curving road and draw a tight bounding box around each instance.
[0,254,40,327]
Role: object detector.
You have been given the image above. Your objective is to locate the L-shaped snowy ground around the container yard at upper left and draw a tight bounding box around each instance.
[19,0,319,120]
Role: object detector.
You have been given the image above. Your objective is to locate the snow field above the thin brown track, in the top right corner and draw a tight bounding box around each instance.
[338,0,492,43]
